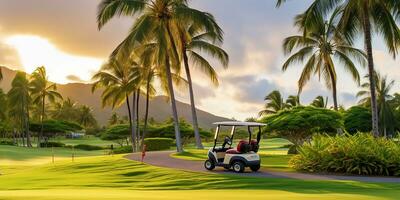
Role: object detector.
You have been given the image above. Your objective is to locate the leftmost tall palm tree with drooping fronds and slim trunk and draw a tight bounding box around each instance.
[7,72,32,147]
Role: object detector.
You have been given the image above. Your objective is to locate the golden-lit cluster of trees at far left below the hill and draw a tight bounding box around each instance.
[0,66,97,147]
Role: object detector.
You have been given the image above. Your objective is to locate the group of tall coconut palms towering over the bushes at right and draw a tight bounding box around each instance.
[277,0,400,137]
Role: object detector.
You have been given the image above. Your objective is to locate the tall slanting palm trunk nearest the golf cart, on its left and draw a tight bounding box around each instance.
[182,49,204,149]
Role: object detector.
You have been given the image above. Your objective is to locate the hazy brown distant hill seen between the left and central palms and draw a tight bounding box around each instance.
[0,68,227,130]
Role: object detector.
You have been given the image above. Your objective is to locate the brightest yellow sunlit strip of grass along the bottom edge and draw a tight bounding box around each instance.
[0,189,386,200]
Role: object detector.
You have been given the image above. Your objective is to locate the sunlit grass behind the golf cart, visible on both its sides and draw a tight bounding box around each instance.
[177,138,293,171]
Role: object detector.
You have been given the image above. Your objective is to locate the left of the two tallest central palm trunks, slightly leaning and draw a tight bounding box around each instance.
[165,25,183,152]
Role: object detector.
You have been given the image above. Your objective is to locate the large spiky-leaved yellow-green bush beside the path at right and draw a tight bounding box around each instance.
[289,133,400,176]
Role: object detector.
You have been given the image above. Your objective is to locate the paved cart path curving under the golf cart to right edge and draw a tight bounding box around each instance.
[125,151,400,183]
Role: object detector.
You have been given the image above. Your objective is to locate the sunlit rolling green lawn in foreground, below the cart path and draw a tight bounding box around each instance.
[0,156,400,200]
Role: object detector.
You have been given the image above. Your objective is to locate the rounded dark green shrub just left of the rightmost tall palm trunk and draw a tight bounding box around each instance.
[343,106,372,134]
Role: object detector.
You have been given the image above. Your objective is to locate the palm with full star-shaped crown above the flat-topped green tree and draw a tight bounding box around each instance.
[282,9,365,110]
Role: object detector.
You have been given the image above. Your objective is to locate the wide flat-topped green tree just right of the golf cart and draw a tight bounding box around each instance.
[261,106,343,153]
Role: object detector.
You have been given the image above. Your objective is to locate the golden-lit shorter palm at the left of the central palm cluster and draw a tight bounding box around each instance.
[92,59,138,151]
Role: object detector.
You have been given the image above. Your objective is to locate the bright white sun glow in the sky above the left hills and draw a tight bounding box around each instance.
[5,35,103,83]
